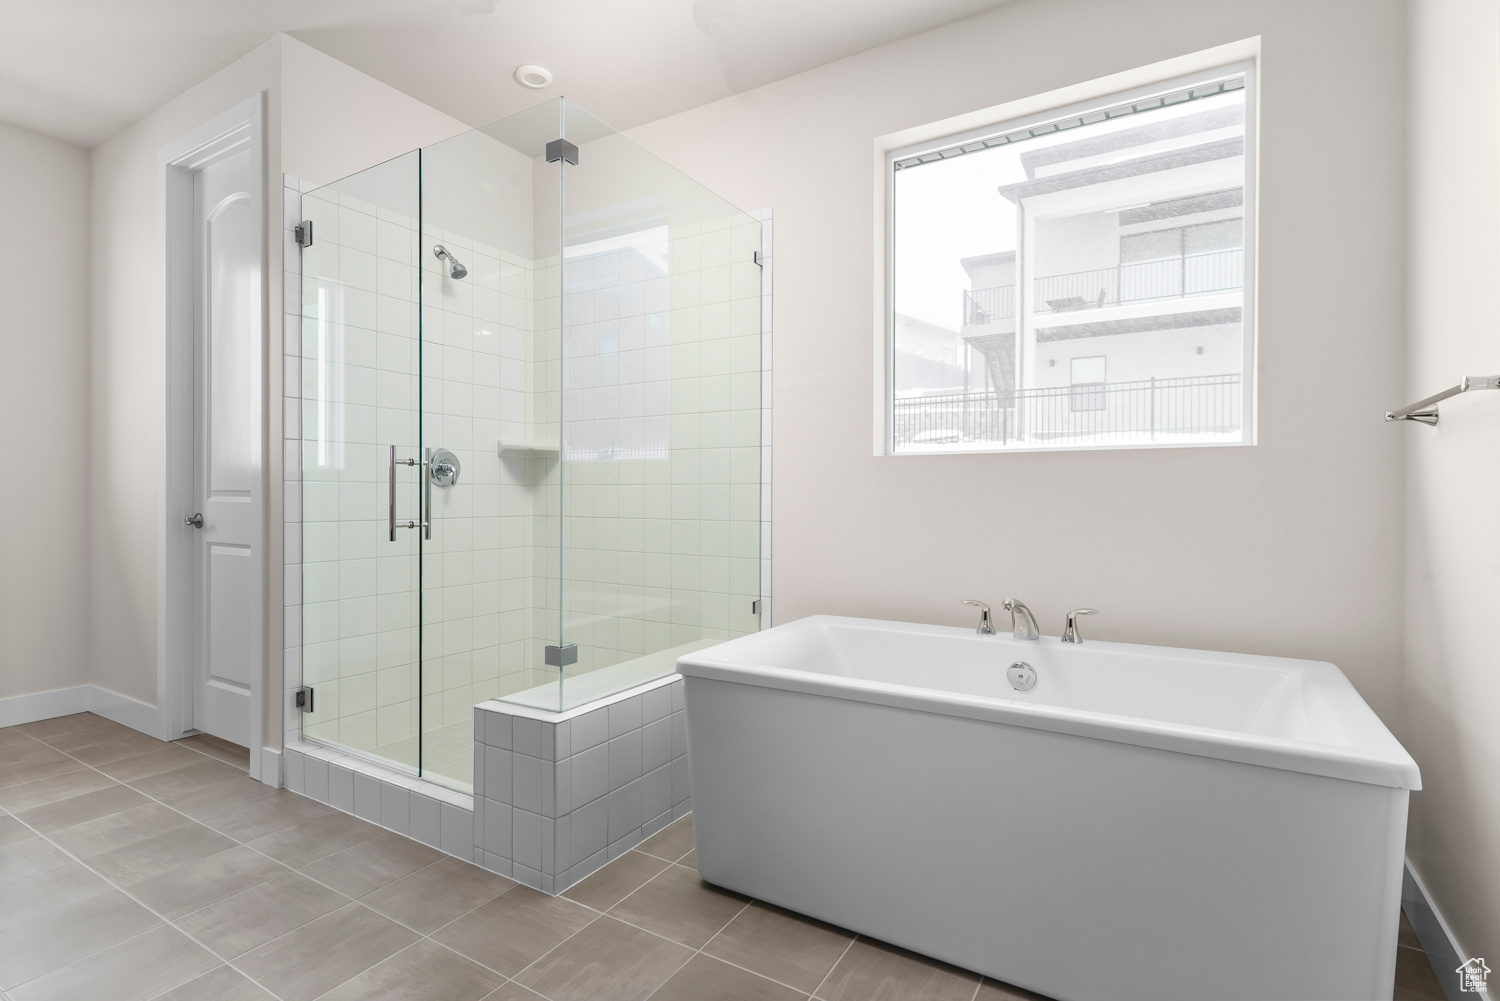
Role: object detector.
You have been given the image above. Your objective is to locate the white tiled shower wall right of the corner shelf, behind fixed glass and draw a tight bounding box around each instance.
[534,213,771,674]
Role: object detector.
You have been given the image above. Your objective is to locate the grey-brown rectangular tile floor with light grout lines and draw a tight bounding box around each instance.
[0,713,1443,1001]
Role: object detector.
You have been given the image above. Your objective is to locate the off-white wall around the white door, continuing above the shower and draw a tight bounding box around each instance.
[87,35,465,747]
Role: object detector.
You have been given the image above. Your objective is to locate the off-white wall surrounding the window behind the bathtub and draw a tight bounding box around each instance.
[632,0,1404,720]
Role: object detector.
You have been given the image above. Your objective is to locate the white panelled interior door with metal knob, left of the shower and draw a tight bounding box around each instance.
[191,144,264,747]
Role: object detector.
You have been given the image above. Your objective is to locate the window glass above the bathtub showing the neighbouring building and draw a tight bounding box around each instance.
[887,65,1254,453]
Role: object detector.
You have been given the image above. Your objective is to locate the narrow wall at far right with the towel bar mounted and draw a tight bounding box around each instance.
[1392,0,1500,963]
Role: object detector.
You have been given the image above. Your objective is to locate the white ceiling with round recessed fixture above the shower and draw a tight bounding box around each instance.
[0,0,1004,147]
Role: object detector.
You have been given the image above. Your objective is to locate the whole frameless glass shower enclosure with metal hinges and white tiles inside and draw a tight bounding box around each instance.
[300,99,762,791]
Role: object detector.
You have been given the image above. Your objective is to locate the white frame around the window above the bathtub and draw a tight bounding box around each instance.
[875,48,1260,456]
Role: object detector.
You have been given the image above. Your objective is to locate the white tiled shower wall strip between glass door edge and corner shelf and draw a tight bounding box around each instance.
[422,230,536,729]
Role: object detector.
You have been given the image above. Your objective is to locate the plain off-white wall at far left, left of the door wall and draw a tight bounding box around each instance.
[0,125,89,699]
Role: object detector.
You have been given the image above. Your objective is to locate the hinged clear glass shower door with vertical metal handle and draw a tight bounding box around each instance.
[300,152,422,773]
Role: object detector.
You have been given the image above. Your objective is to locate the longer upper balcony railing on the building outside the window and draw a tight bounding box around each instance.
[1032,249,1245,312]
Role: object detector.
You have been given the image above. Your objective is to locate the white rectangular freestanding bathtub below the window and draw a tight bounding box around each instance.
[678,615,1421,1001]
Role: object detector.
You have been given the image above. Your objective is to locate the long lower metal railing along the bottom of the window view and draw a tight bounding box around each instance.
[893,374,1244,452]
